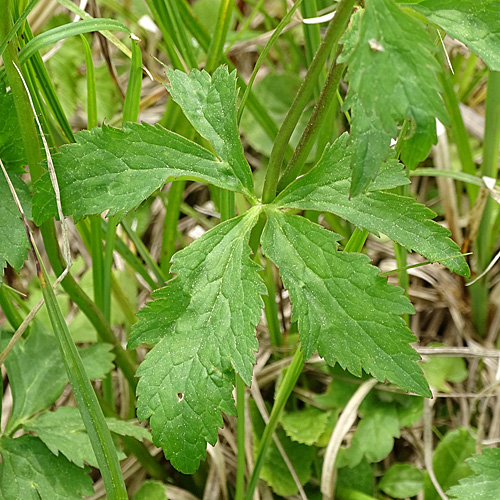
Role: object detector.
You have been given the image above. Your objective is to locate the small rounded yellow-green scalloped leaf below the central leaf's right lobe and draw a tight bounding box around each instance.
[281,408,331,446]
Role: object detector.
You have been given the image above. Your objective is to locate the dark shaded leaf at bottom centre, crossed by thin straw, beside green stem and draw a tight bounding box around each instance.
[249,400,316,497]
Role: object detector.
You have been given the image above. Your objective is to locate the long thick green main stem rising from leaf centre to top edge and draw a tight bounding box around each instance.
[262,0,356,203]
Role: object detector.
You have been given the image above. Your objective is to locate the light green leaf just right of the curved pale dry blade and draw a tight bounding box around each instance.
[336,400,400,467]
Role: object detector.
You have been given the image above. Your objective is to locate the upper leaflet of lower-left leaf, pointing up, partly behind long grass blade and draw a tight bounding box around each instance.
[0,323,114,431]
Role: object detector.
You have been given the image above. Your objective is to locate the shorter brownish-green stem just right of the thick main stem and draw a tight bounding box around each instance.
[278,61,345,191]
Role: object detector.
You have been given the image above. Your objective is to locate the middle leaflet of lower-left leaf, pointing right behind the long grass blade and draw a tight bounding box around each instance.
[23,406,151,467]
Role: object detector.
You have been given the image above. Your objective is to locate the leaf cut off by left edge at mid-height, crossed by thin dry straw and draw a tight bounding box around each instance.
[0,176,31,277]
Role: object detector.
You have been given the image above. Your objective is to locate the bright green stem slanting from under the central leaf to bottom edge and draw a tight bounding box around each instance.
[245,349,304,500]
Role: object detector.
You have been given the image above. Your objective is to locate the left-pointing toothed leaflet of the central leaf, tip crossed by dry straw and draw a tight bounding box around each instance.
[33,123,246,224]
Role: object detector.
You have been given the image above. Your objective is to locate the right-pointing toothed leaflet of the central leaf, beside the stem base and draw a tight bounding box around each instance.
[275,134,470,276]
